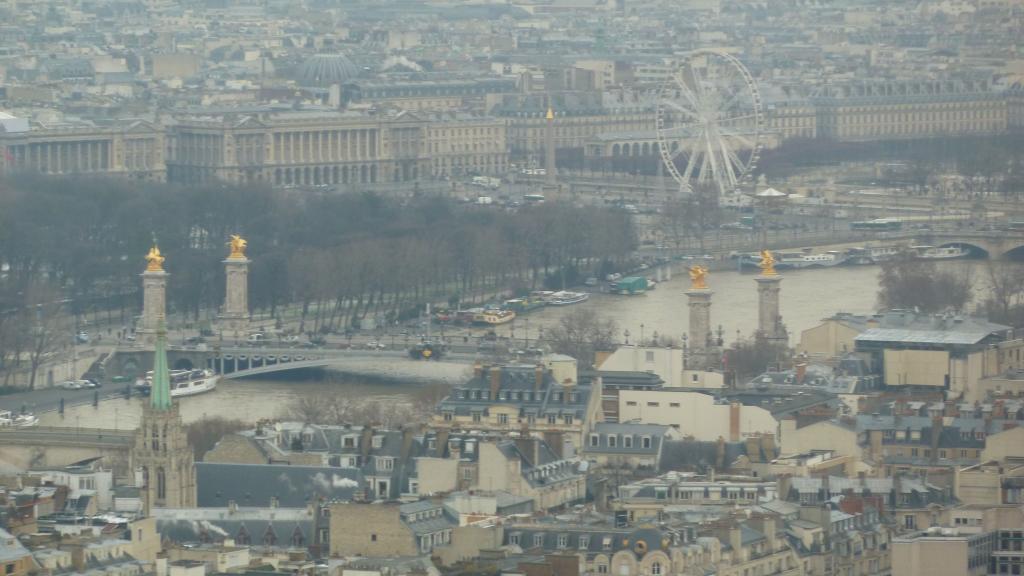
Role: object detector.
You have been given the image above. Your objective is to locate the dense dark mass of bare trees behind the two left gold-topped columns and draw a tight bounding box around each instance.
[0,175,635,381]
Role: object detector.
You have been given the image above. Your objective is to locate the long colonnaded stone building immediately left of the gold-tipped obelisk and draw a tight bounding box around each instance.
[167,105,508,181]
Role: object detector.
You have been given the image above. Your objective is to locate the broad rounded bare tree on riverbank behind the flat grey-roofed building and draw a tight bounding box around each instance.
[879,255,971,313]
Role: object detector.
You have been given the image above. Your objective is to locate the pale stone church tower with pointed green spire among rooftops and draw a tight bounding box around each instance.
[132,243,196,508]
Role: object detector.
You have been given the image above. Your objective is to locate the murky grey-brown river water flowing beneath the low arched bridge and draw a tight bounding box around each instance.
[41,261,985,429]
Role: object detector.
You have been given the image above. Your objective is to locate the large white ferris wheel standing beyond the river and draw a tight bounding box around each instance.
[656,49,764,196]
